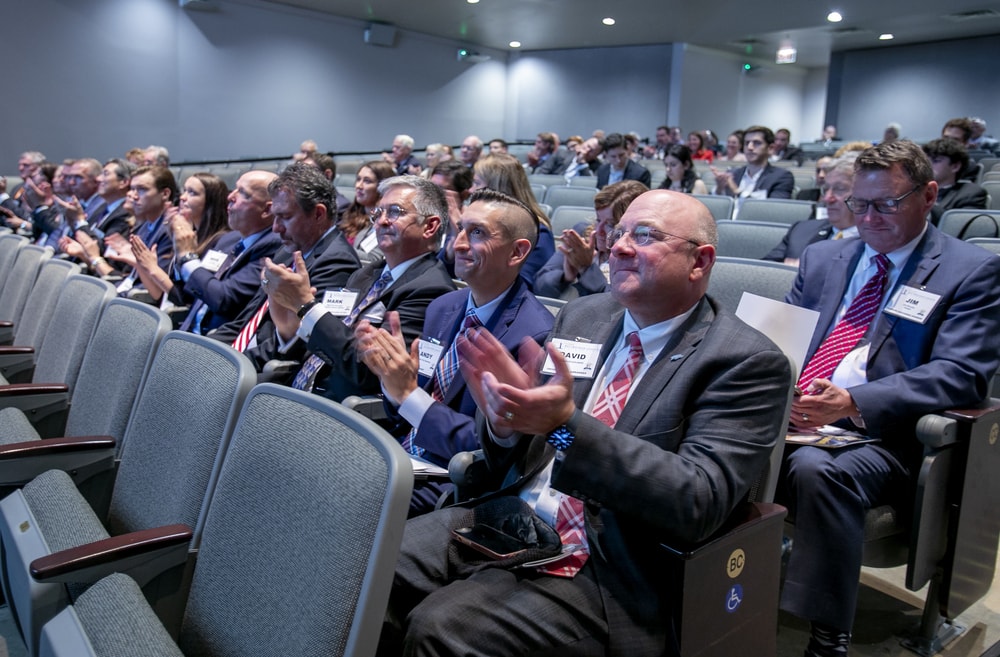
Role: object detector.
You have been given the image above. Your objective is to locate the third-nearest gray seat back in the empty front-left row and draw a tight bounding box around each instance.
[66,299,170,444]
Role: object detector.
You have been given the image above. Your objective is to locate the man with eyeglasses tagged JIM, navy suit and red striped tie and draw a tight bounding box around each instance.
[779,140,1000,657]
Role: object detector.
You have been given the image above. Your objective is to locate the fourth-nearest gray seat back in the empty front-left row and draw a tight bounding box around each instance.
[26,276,115,393]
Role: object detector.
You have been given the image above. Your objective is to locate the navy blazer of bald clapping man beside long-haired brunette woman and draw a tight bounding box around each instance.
[176,231,281,333]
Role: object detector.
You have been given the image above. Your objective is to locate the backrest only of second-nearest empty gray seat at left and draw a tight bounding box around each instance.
[107,331,257,534]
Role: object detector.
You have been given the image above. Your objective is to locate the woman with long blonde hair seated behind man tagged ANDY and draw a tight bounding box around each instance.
[470,153,556,287]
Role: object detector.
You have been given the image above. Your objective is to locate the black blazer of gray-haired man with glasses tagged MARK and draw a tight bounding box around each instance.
[302,253,455,401]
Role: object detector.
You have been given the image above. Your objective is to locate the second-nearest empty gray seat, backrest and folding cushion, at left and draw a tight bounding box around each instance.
[0,331,256,650]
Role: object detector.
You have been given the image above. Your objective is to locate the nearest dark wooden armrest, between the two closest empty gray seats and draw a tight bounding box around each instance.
[30,525,194,583]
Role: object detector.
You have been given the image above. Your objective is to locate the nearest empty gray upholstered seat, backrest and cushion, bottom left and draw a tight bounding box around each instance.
[41,384,413,657]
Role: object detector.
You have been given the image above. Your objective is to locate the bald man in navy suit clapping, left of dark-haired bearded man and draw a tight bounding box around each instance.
[174,171,281,335]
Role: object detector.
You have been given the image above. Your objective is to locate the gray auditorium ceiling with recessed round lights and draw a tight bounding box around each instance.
[252,0,1000,67]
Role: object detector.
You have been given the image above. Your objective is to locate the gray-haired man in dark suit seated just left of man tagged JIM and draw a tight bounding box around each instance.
[764,158,858,266]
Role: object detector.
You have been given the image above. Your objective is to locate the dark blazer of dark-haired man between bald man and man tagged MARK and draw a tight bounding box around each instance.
[210,230,361,344]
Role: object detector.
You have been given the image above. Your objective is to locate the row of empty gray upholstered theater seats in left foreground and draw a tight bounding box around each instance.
[0,236,413,655]
